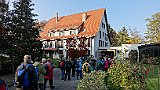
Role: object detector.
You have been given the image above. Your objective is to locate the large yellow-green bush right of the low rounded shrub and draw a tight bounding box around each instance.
[107,59,143,90]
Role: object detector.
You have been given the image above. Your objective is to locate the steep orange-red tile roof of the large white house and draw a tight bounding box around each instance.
[40,8,105,39]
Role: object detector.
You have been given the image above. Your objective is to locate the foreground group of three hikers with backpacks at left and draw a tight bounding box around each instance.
[15,55,55,90]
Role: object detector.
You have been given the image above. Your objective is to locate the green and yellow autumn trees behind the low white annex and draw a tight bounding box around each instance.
[109,27,144,46]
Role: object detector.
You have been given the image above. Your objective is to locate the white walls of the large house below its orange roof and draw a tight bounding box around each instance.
[43,15,110,58]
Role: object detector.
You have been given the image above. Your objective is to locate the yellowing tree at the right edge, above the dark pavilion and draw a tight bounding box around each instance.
[145,12,160,43]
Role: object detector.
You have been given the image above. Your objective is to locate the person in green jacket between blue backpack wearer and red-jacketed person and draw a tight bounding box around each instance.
[33,58,46,90]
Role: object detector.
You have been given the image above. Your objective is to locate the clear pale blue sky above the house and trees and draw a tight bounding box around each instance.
[11,0,160,34]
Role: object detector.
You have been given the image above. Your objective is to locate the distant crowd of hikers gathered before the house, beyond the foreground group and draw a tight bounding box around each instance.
[59,55,114,81]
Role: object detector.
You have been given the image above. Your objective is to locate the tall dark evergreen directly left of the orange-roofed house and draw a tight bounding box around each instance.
[12,0,42,60]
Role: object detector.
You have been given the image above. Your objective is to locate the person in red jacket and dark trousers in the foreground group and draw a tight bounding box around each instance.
[44,58,55,89]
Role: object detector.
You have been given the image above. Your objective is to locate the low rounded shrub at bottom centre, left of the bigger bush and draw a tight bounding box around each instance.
[77,71,107,90]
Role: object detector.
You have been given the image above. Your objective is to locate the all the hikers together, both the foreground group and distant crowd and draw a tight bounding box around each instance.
[0,55,114,90]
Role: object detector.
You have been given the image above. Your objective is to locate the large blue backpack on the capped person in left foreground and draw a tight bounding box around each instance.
[17,64,31,87]
